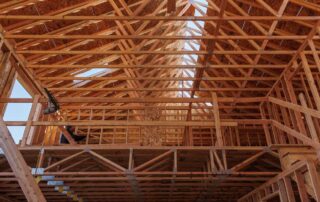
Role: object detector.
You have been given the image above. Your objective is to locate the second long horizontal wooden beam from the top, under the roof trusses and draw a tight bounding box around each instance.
[4,34,320,40]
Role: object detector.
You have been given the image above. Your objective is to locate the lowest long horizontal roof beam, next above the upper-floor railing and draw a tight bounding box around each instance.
[0,97,268,103]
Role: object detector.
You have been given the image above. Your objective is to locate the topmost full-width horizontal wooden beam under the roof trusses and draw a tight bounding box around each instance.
[0,15,320,21]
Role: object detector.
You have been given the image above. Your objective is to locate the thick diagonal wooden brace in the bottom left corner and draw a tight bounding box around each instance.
[0,117,46,202]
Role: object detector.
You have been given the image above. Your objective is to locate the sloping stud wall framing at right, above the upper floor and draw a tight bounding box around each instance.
[260,51,320,158]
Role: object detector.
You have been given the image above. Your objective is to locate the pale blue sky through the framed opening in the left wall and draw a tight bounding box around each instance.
[3,80,31,144]
